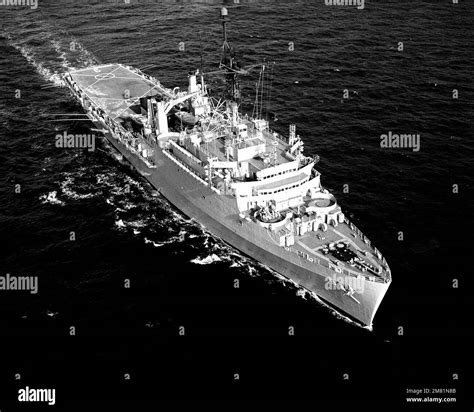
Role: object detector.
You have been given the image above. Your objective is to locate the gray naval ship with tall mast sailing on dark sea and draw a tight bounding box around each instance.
[63,8,391,328]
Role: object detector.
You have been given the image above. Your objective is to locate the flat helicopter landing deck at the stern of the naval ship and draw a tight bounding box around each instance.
[69,64,163,119]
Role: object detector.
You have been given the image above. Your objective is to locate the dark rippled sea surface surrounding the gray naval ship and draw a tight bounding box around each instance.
[0,0,474,406]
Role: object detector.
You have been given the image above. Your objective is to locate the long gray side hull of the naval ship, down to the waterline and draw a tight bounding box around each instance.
[94,121,390,327]
